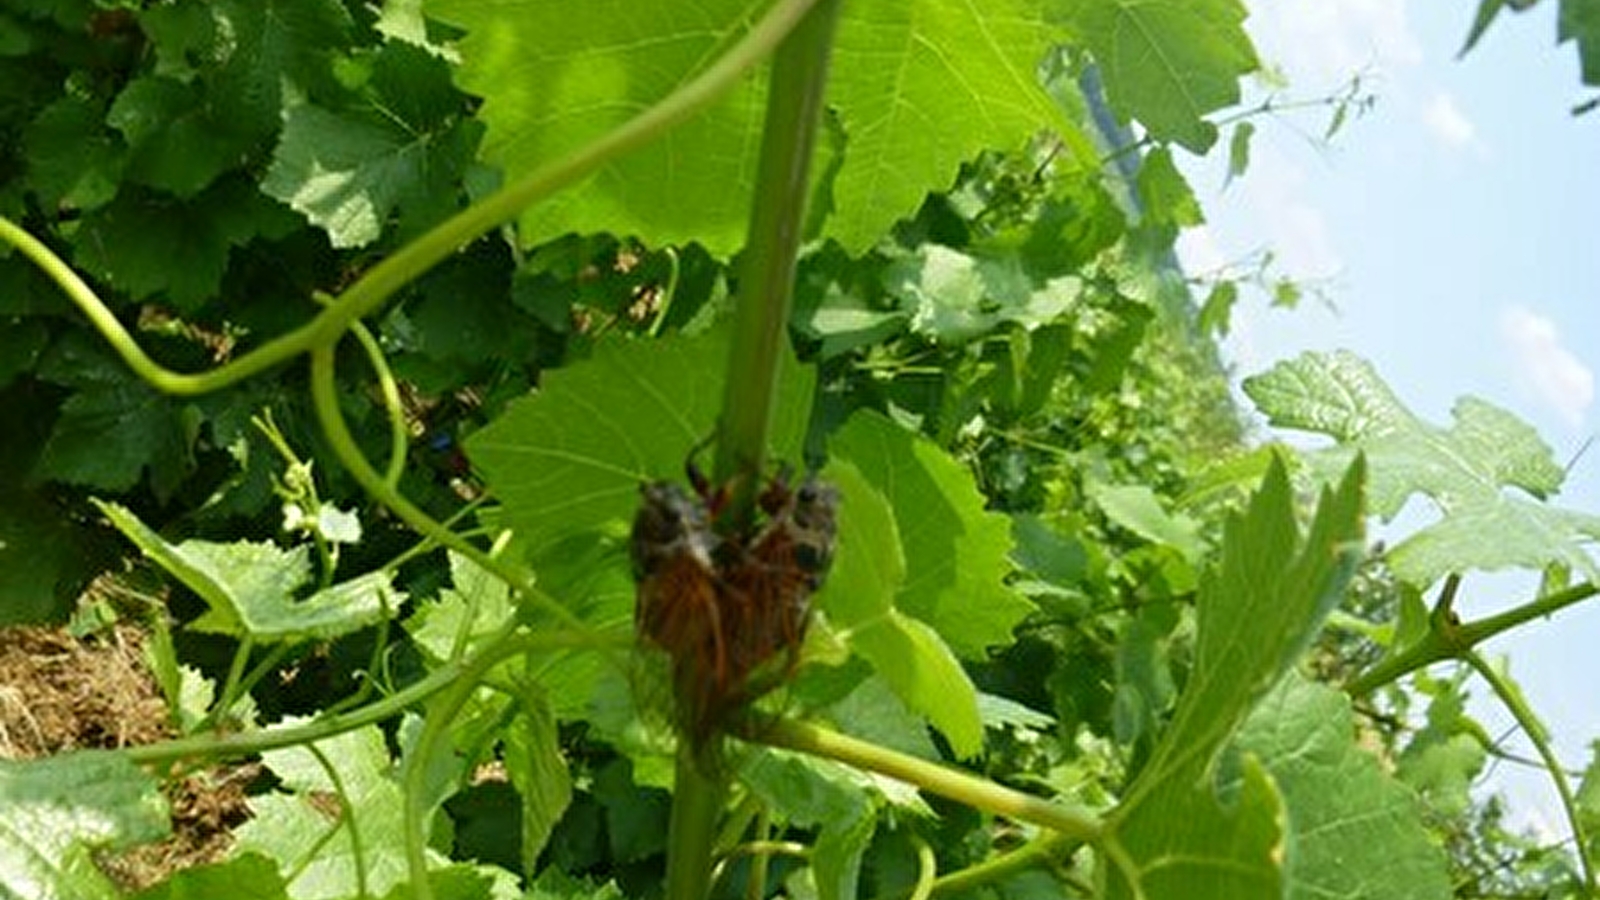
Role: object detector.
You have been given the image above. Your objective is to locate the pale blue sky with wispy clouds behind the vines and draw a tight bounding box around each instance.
[1181,0,1600,834]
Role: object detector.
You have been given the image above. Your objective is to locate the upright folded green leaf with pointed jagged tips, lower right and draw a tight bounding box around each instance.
[1107,461,1363,900]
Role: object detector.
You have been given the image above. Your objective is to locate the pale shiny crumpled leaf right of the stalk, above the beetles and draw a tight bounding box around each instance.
[883,243,1083,344]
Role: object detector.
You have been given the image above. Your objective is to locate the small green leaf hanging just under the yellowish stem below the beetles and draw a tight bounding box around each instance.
[739,749,878,900]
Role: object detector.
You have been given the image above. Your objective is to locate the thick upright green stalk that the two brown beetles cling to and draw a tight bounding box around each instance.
[667,0,838,900]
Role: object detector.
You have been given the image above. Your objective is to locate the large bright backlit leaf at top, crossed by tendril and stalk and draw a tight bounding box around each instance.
[427,0,1070,255]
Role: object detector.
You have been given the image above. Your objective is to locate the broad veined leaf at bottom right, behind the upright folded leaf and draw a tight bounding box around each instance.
[1235,673,1453,900]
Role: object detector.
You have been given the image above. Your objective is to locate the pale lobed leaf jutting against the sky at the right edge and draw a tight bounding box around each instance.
[1245,351,1600,586]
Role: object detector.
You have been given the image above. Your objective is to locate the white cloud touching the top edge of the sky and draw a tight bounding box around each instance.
[1246,0,1422,90]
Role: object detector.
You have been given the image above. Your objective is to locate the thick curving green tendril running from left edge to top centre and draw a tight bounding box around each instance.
[0,0,818,394]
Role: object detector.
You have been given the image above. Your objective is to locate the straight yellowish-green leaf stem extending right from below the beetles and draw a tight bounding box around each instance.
[742,719,1107,844]
